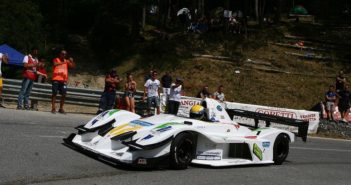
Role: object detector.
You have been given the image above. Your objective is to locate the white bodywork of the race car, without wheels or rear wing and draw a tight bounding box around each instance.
[67,99,294,166]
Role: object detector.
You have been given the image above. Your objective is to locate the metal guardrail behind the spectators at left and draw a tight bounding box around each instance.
[3,79,146,110]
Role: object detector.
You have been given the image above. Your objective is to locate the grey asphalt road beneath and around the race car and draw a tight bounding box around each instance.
[0,109,351,185]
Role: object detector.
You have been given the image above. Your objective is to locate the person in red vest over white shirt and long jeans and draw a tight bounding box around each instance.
[17,48,46,110]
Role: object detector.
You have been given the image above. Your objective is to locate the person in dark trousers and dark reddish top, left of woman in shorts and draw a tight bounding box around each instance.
[96,70,120,114]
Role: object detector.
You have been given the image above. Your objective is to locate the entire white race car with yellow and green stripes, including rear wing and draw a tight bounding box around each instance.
[64,99,308,169]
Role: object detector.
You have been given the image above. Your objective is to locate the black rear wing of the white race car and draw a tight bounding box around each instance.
[226,109,309,142]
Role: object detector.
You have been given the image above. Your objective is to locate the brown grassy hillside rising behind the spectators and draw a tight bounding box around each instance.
[66,23,351,109]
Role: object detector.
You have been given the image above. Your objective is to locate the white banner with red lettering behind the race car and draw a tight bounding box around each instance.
[161,96,319,133]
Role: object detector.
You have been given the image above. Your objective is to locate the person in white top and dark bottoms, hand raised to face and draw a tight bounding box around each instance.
[167,78,183,115]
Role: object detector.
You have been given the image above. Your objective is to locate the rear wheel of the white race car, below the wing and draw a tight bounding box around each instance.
[273,134,290,165]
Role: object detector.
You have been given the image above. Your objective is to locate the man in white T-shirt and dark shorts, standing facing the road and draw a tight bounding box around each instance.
[143,71,160,115]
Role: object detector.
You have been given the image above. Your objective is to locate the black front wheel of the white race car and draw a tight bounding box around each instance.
[170,132,195,170]
